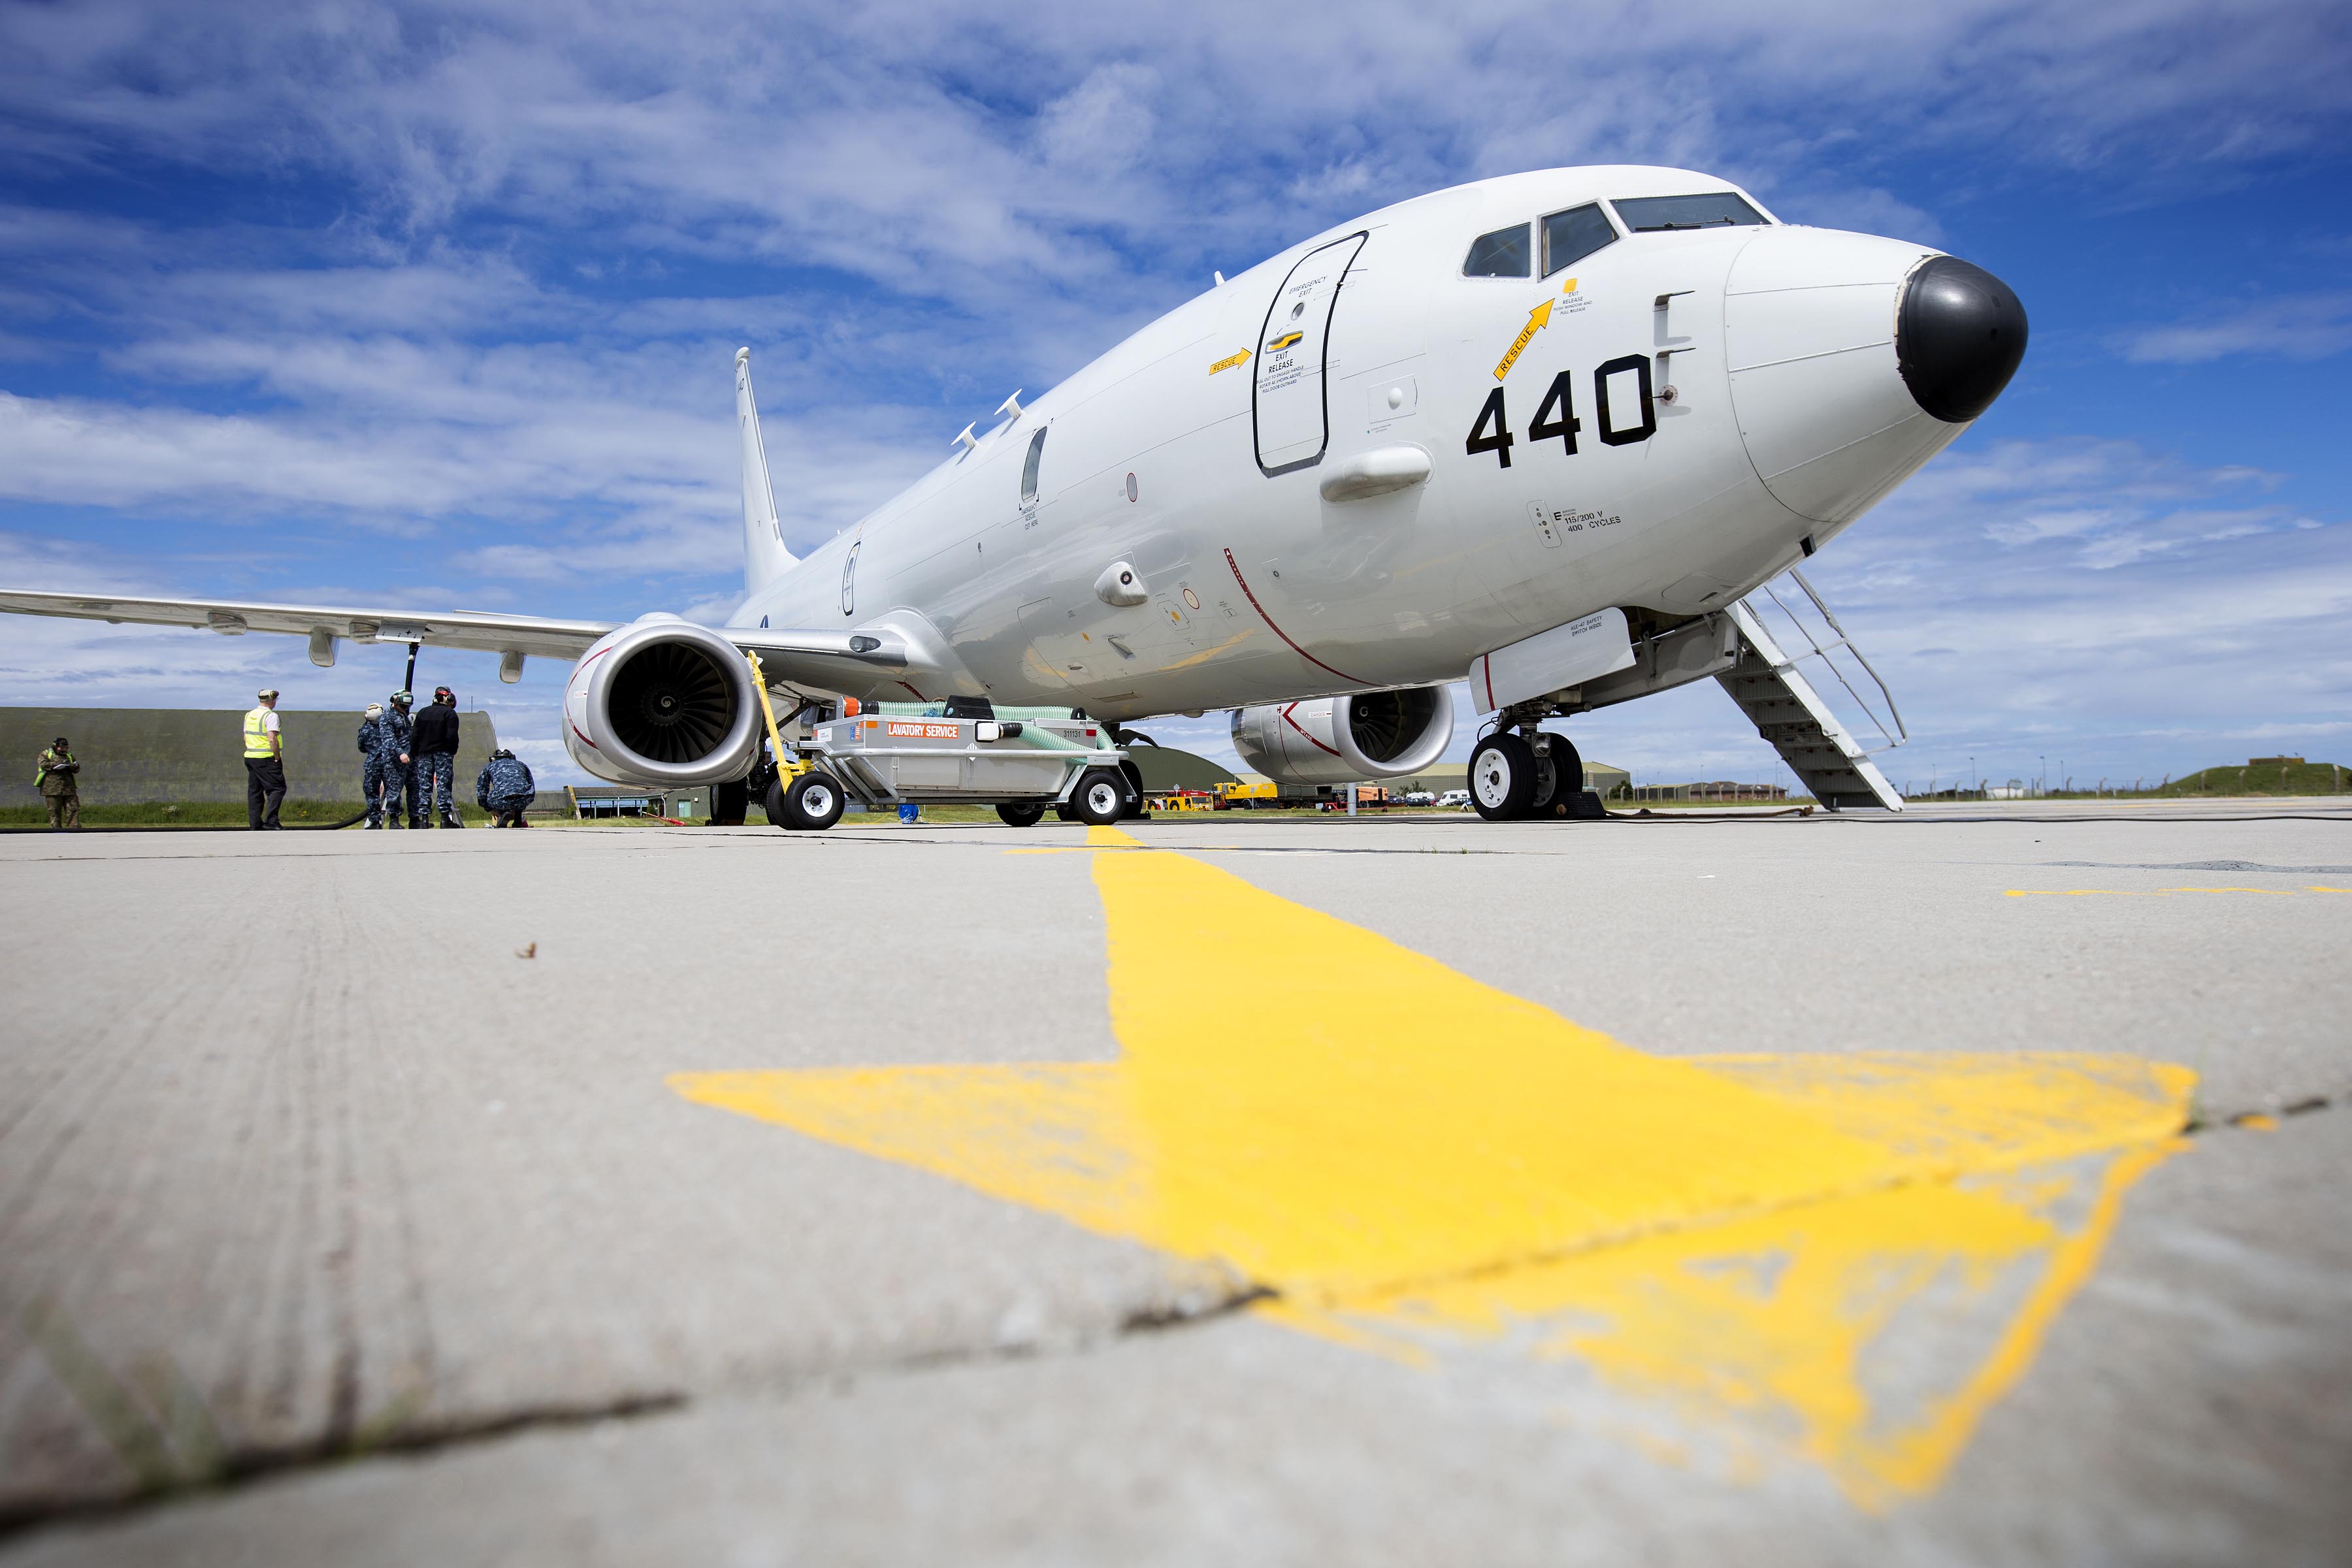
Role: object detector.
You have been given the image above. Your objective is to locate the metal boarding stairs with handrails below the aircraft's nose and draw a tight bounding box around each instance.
[1714,569,1910,811]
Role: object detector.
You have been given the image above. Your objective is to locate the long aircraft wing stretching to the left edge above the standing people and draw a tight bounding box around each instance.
[0,588,924,691]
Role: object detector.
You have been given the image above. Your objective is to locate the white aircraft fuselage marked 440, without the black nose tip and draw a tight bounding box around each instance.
[734,167,1967,719]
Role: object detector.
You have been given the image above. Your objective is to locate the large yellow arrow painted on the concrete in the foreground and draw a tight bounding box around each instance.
[670,828,2195,1507]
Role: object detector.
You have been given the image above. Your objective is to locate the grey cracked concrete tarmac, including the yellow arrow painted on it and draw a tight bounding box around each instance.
[0,802,2352,1563]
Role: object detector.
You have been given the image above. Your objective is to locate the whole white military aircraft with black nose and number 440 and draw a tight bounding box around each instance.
[0,167,2025,825]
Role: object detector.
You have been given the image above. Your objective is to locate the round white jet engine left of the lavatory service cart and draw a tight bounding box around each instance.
[564,613,760,787]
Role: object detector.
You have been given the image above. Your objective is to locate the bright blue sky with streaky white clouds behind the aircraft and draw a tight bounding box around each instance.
[0,0,2352,785]
